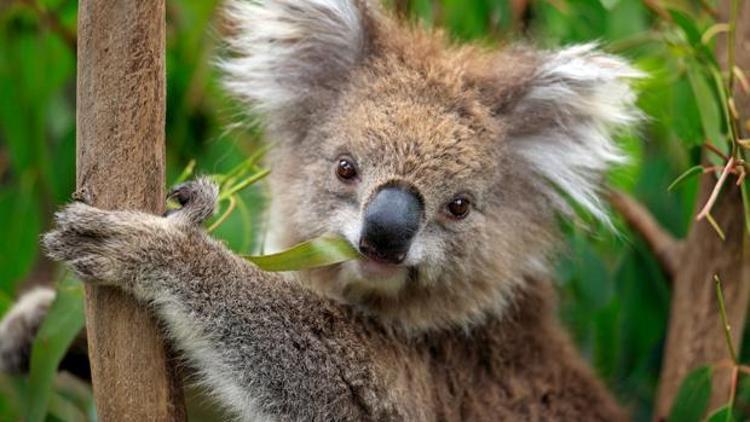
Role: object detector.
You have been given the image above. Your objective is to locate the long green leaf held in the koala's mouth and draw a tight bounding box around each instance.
[243,235,360,271]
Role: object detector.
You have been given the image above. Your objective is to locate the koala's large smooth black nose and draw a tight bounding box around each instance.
[359,187,422,264]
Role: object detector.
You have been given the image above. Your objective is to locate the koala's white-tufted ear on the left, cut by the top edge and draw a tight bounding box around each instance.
[219,0,377,126]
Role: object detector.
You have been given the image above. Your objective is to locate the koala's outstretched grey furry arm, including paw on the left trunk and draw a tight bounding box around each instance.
[44,181,391,420]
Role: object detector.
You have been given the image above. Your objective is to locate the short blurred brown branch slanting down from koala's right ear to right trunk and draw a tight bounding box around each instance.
[609,191,683,279]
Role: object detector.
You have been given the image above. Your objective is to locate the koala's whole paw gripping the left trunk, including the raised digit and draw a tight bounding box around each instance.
[42,178,218,289]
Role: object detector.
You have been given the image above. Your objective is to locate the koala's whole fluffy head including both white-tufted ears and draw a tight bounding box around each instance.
[222,0,639,329]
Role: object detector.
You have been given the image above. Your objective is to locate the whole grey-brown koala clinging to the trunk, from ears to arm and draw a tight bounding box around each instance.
[5,0,639,421]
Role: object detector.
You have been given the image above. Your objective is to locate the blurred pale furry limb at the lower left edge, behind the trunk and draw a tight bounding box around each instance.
[0,287,55,374]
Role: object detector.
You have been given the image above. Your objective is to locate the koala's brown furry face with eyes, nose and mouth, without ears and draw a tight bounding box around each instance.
[287,66,516,301]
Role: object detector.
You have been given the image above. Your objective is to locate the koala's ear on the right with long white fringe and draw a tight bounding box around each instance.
[509,44,644,222]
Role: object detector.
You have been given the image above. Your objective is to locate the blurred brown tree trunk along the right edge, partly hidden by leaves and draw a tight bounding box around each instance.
[654,0,750,419]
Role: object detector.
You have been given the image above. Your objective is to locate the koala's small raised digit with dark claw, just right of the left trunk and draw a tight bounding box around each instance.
[166,177,219,224]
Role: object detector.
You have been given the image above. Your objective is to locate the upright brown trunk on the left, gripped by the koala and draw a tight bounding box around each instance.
[76,0,185,421]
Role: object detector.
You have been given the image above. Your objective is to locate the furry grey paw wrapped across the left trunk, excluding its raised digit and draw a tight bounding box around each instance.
[42,202,174,287]
